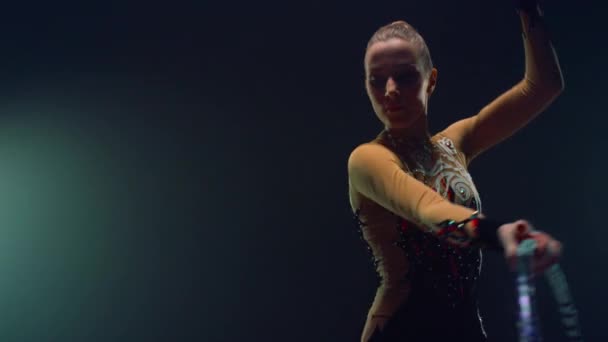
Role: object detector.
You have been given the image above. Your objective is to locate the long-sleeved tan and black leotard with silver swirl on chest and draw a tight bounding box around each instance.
[348,8,563,341]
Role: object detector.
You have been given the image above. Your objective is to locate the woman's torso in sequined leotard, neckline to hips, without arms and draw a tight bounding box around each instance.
[350,132,481,317]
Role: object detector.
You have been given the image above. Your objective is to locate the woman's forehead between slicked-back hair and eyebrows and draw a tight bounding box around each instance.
[365,38,419,71]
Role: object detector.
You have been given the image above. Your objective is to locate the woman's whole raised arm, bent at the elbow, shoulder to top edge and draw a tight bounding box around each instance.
[443,0,564,161]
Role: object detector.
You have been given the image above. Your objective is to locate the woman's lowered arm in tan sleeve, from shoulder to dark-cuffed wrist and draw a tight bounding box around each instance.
[348,144,508,248]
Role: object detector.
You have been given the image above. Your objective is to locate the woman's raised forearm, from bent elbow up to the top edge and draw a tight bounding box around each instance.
[518,0,564,94]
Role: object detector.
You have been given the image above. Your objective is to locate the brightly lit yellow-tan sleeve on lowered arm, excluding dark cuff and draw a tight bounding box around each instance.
[348,143,474,232]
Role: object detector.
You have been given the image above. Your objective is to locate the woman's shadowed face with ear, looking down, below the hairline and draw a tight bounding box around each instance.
[365,38,437,129]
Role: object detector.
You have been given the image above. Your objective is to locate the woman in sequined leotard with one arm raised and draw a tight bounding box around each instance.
[348,0,563,341]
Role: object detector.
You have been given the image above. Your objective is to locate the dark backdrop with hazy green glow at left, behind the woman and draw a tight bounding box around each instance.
[0,0,608,341]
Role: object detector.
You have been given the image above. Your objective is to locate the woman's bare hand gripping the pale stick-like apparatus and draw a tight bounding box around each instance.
[498,220,562,274]
